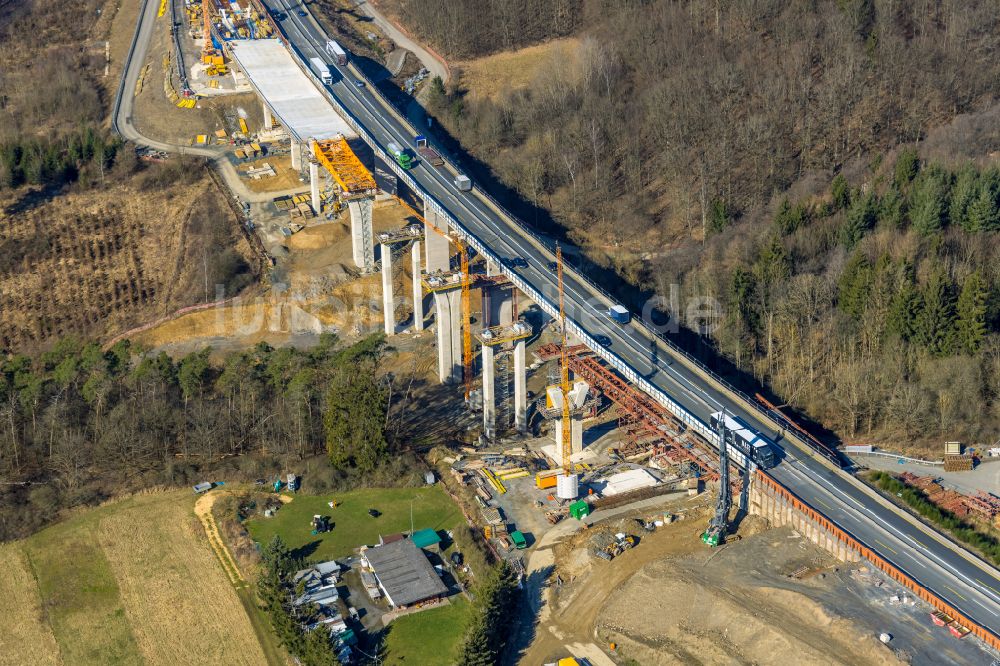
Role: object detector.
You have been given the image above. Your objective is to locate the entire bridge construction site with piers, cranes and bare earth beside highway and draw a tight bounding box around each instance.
[105,0,995,664]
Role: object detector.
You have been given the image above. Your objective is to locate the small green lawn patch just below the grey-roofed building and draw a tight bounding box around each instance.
[383,595,472,664]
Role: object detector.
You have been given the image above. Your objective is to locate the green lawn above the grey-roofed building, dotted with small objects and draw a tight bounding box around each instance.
[247,486,463,560]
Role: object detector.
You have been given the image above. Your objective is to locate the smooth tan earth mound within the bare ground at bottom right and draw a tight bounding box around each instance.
[597,548,902,665]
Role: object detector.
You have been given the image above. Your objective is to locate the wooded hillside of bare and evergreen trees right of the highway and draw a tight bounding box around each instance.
[403,0,1000,450]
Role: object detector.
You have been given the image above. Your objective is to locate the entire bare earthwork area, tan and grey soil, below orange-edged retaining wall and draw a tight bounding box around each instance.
[504,488,983,664]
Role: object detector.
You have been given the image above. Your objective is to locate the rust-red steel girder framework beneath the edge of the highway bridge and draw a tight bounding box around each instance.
[535,344,719,481]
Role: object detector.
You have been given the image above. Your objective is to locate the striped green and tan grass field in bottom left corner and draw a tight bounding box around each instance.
[0,490,281,666]
